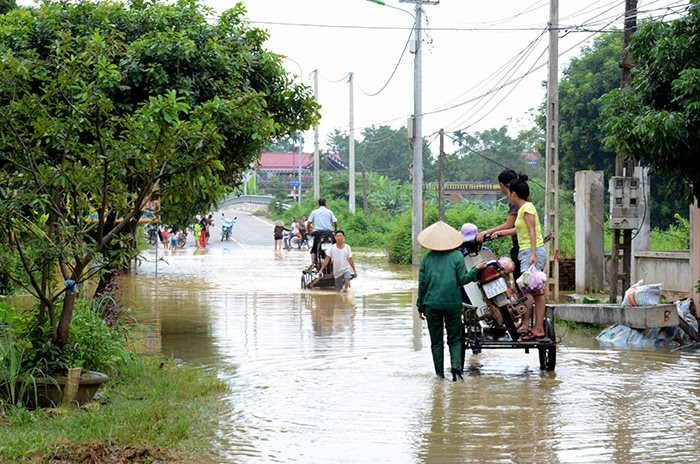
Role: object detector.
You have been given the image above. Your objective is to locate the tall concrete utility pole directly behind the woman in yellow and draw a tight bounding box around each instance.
[544,0,559,301]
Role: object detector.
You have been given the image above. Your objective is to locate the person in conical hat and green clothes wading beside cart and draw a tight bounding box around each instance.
[416,221,484,381]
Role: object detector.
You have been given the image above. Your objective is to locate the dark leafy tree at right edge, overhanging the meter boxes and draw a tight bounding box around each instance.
[603,0,700,200]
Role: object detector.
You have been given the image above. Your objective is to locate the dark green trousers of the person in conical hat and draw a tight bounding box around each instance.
[424,308,462,376]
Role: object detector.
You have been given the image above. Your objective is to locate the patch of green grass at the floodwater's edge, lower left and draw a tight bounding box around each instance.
[0,357,226,462]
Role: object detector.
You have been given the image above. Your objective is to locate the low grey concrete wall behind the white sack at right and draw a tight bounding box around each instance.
[605,251,693,295]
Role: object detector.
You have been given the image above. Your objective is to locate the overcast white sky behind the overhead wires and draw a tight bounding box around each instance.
[18,0,687,152]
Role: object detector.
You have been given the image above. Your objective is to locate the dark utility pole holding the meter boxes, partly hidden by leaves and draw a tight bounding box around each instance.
[610,0,637,303]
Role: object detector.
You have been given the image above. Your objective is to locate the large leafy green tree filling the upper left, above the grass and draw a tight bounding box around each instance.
[0,0,318,346]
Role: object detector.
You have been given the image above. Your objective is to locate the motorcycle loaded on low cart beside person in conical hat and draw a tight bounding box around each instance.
[461,235,557,371]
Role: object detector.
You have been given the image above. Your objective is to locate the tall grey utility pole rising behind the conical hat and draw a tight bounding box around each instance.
[400,0,440,266]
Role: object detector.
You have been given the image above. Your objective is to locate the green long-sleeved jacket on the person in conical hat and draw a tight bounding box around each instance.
[416,250,478,313]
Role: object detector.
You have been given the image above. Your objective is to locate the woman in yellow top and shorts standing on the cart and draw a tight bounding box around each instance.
[491,174,547,340]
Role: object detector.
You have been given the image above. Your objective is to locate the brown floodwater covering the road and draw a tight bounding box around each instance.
[121,213,700,463]
